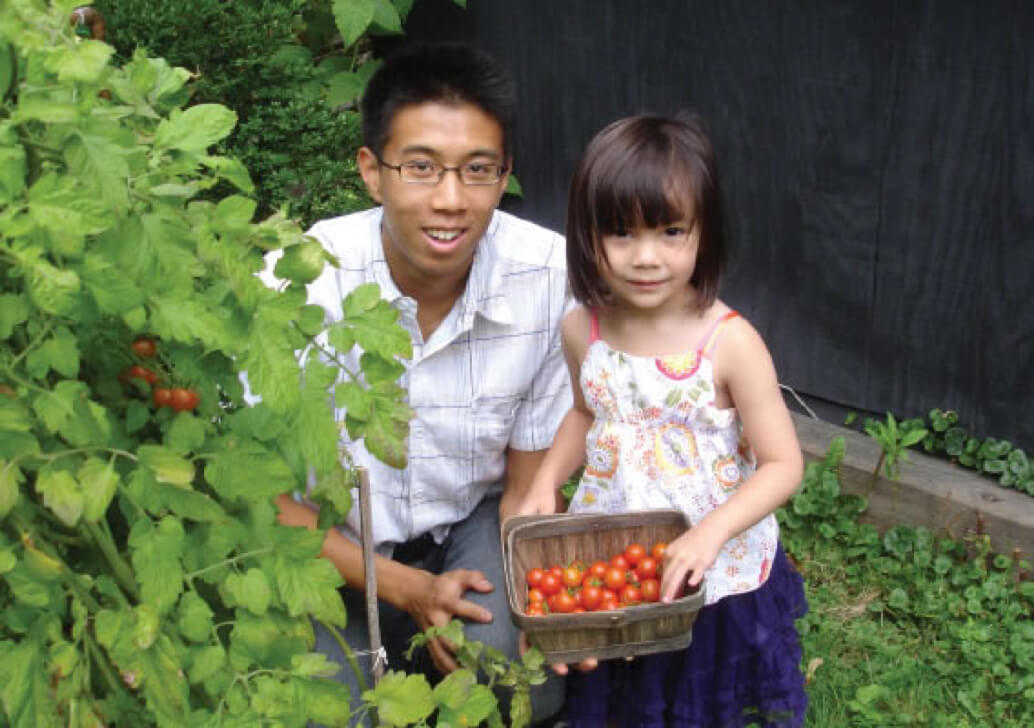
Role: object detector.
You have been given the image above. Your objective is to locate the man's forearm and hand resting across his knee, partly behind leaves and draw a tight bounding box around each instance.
[276,493,492,674]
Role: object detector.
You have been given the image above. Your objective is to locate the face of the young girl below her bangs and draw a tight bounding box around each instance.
[601,218,700,312]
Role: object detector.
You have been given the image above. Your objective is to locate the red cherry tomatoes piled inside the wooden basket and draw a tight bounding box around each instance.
[525,543,667,616]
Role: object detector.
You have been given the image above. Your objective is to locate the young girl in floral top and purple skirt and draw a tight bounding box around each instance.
[533,117,808,728]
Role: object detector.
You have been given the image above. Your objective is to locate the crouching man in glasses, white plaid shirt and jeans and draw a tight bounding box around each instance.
[270,44,571,720]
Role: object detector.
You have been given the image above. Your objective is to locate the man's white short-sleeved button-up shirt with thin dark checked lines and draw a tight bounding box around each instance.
[308,208,572,554]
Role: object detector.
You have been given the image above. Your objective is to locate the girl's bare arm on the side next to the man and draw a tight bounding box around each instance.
[499,306,592,520]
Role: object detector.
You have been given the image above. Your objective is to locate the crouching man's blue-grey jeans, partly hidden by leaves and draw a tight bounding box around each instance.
[313,495,564,726]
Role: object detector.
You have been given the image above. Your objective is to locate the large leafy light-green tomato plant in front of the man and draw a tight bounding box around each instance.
[0,0,419,726]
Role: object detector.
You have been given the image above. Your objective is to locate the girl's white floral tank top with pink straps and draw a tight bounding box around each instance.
[569,311,779,604]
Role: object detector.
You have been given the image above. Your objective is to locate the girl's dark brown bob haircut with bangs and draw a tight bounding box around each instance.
[566,114,726,308]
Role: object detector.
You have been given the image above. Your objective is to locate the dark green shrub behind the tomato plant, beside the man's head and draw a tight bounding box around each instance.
[96,0,399,225]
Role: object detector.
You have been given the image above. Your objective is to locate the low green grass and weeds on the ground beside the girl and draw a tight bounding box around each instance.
[779,438,1034,727]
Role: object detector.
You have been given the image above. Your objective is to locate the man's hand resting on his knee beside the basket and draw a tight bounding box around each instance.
[405,569,495,675]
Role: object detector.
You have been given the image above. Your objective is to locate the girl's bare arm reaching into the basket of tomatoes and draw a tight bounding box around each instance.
[661,319,803,601]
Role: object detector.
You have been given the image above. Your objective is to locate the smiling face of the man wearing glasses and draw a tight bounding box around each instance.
[358,102,508,296]
